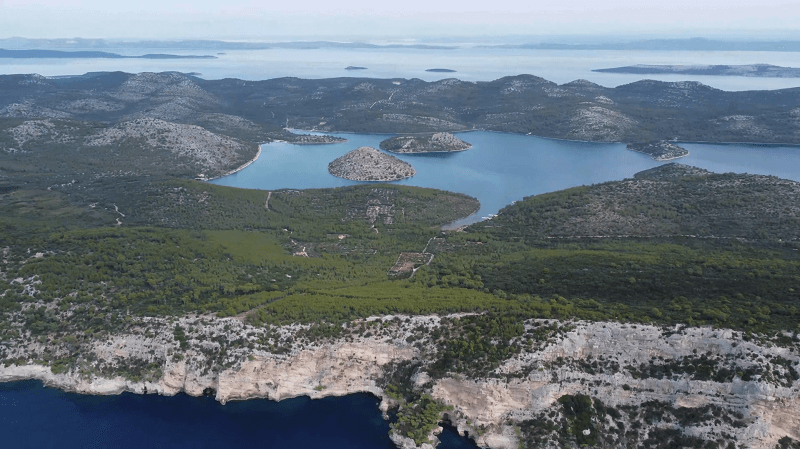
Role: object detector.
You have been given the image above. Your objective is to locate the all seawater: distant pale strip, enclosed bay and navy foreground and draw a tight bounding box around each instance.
[0,43,800,449]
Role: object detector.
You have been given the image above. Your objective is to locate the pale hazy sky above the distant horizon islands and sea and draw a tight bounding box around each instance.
[0,0,800,39]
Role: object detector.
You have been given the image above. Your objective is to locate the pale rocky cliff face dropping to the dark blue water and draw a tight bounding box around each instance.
[0,316,800,449]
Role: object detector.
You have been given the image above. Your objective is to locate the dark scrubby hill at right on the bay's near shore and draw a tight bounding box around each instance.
[475,163,800,240]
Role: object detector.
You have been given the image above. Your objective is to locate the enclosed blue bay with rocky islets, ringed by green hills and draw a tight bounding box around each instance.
[211,131,800,228]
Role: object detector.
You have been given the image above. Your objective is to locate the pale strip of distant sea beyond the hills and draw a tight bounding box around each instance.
[0,46,800,91]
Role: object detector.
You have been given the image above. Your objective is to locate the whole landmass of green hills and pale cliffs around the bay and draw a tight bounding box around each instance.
[0,73,800,449]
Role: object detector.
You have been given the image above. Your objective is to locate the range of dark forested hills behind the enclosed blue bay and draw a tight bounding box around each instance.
[0,72,800,143]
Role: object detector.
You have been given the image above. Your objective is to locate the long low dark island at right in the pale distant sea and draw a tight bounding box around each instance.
[592,64,800,78]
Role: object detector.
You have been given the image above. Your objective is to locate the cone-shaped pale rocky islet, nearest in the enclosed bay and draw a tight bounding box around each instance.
[328,147,417,181]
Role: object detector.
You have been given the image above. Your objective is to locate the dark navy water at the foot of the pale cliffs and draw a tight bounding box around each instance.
[0,381,475,449]
